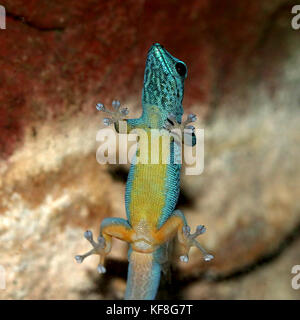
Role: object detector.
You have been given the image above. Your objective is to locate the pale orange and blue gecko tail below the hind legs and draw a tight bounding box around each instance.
[125,251,161,300]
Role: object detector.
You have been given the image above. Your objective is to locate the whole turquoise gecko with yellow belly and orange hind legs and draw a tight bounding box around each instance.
[75,43,213,300]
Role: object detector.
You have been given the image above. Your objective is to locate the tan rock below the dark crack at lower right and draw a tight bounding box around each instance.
[182,235,300,300]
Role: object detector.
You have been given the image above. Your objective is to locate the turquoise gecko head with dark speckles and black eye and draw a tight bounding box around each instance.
[142,43,187,122]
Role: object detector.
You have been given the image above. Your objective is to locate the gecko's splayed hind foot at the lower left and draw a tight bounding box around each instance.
[75,230,107,273]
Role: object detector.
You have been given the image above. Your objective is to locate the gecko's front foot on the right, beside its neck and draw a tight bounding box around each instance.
[164,113,197,143]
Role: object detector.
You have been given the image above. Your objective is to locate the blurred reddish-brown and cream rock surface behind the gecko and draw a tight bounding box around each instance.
[0,0,300,299]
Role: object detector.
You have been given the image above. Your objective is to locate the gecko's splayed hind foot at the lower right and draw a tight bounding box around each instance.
[180,225,214,262]
